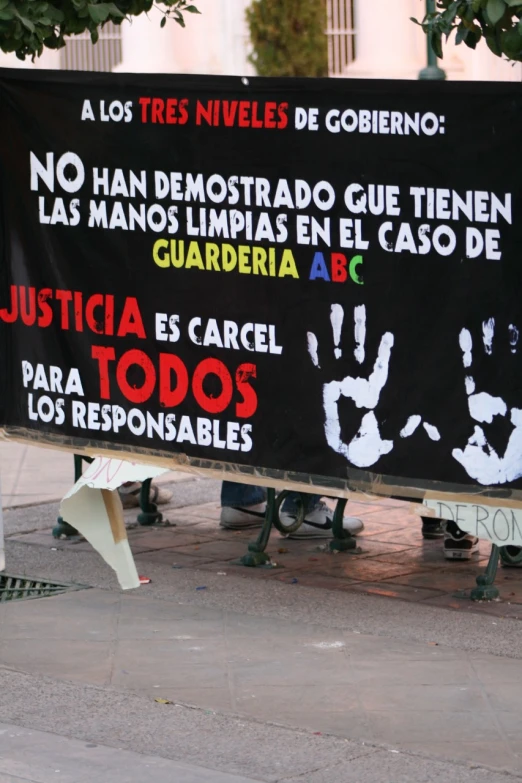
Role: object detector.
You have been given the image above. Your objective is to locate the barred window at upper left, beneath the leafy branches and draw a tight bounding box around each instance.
[60,22,122,71]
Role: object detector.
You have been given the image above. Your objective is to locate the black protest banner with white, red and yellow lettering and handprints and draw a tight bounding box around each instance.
[0,71,522,494]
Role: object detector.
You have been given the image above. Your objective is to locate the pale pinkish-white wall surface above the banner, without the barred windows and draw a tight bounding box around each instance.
[0,0,522,81]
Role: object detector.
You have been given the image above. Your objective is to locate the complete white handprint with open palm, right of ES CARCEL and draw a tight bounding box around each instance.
[308,304,394,468]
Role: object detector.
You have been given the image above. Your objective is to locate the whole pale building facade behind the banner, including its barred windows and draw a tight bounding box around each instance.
[0,0,522,81]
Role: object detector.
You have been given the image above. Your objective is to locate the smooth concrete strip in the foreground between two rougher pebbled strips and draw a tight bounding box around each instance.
[0,584,522,774]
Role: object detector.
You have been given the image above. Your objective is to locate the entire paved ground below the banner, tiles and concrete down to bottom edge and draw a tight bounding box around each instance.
[0,444,522,783]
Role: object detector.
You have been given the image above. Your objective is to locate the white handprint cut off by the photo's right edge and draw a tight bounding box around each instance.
[452,318,522,485]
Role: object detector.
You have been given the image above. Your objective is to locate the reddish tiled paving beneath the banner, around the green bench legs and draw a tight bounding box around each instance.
[4,443,522,619]
